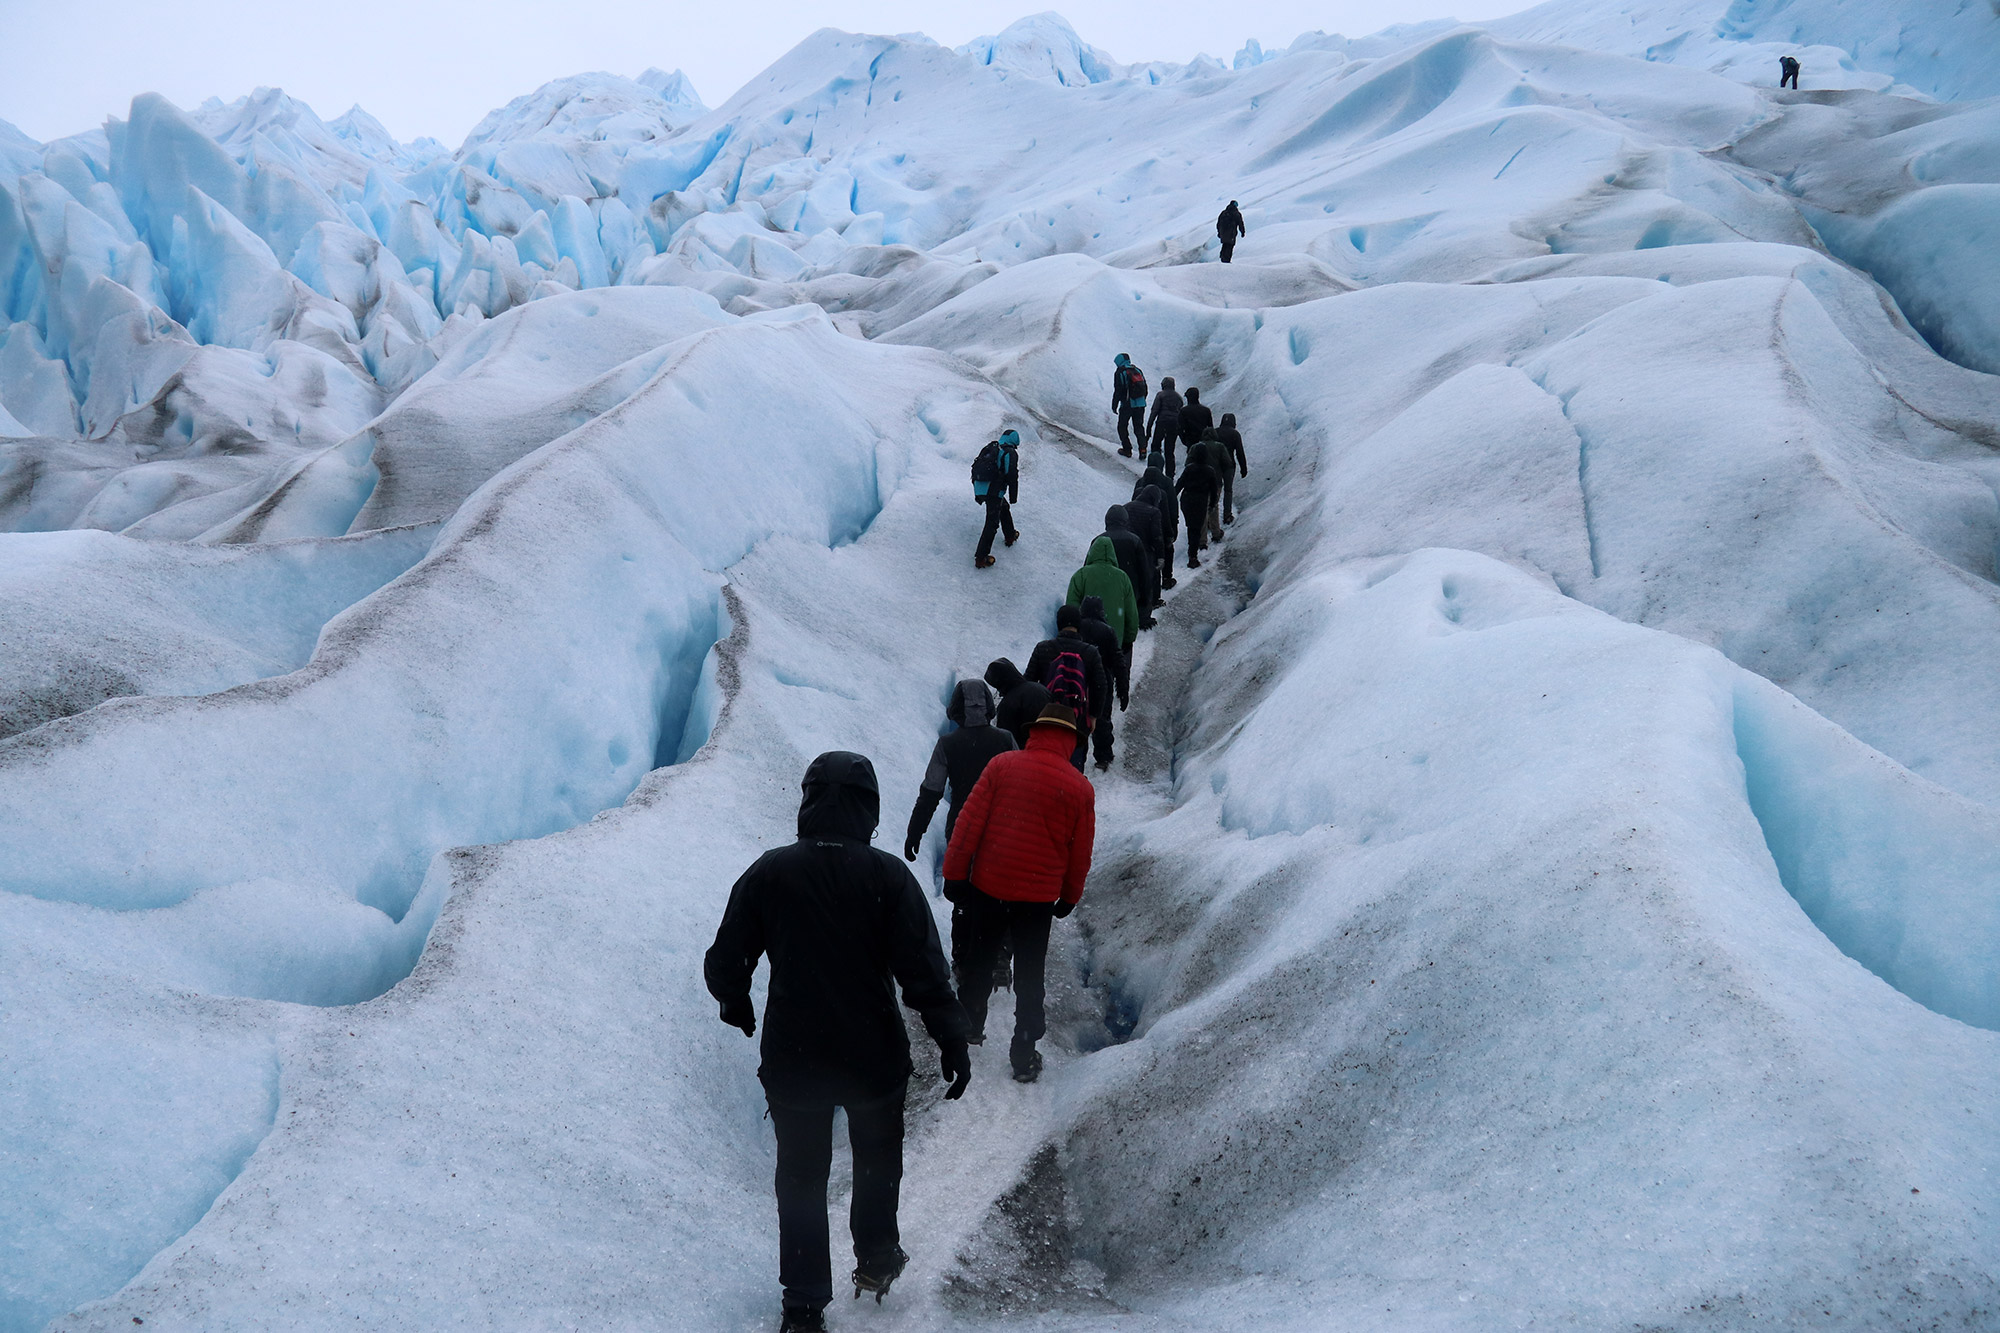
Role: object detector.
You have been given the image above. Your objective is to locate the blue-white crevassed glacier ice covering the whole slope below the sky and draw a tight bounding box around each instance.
[0,0,2000,1333]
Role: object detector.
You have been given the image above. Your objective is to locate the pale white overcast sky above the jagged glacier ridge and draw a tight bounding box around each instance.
[0,0,1534,148]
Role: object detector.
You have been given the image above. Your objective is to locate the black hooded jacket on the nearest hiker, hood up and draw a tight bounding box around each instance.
[702,751,972,1103]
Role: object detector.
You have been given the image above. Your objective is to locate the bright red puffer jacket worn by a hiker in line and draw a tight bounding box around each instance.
[944,723,1098,903]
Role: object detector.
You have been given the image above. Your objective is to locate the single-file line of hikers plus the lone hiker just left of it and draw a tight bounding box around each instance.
[702,352,1248,1333]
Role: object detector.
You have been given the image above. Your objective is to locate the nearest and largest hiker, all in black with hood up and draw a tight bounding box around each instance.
[702,751,972,1333]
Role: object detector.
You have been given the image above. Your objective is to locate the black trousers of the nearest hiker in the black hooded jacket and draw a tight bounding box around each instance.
[770,1079,910,1309]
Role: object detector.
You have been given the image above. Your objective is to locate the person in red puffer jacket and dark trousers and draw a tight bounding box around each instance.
[944,703,1098,1083]
